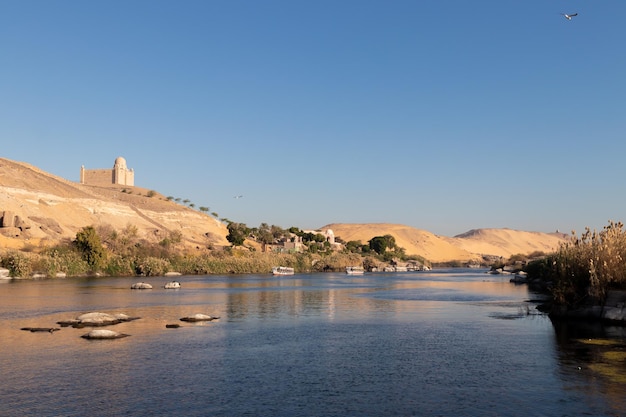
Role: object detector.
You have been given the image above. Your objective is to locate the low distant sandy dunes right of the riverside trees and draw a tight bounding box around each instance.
[322,223,567,262]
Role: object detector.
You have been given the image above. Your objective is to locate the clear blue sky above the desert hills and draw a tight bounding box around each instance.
[0,0,626,236]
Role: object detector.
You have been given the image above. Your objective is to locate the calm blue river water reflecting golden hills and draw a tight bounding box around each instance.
[0,269,626,416]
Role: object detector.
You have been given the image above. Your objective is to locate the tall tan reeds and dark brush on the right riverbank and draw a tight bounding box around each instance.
[525,221,626,308]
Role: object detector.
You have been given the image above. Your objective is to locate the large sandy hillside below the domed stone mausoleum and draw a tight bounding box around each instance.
[0,158,228,249]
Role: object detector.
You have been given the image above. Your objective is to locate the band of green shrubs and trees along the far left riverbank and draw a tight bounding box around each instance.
[0,218,428,277]
